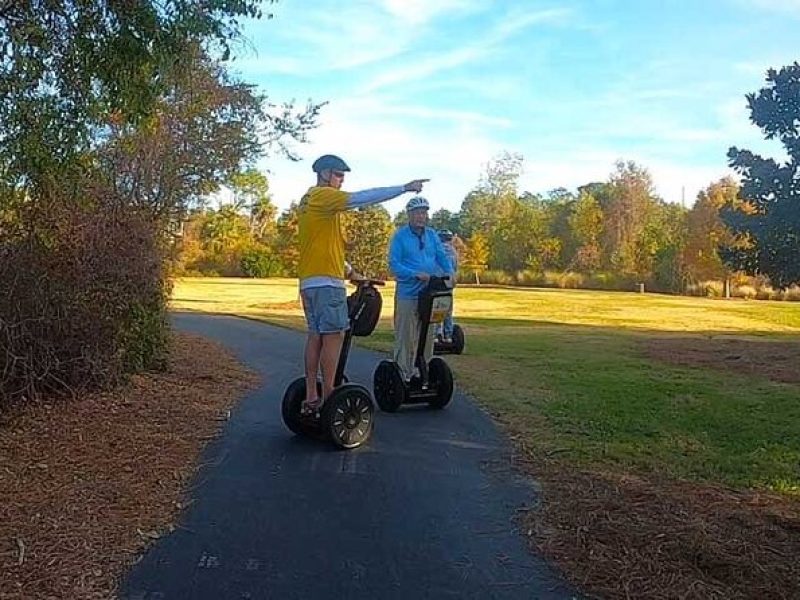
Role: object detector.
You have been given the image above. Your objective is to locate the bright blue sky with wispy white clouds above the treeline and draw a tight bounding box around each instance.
[225,0,800,213]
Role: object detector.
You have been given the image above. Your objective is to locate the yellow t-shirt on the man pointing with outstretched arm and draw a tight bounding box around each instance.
[297,187,349,279]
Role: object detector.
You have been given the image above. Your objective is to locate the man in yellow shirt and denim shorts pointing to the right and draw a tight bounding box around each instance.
[297,154,428,414]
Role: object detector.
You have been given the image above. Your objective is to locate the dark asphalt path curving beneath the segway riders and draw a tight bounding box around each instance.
[120,313,577,600]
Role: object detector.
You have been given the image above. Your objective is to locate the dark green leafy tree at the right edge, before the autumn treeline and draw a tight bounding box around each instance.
[722,62,800,288]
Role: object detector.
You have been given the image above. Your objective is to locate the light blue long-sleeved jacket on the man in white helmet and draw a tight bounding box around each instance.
[389,225,455,299]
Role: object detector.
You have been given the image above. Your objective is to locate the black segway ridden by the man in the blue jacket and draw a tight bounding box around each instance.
[373,277,453,412]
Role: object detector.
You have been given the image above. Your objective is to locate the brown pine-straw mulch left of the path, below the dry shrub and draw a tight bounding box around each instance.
[0,333,257,600]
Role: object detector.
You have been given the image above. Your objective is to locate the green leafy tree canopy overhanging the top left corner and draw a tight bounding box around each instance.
[0,0,273,185]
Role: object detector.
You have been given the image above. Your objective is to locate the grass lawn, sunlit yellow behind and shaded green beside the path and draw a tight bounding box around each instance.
[173,279,800,495]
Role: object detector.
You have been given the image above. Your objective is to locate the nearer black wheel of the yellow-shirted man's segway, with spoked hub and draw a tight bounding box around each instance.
[321,383,375,450]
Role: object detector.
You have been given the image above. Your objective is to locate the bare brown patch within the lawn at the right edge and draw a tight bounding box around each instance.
[642,337,800,383]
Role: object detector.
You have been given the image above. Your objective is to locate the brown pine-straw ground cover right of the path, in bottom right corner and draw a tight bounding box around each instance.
[522,457,800,600]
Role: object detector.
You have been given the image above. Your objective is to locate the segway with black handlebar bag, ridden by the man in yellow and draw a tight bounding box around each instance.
[281,279,384,450]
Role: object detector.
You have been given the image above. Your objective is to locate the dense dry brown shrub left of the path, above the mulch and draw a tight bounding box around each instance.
[0,191,167,401]
